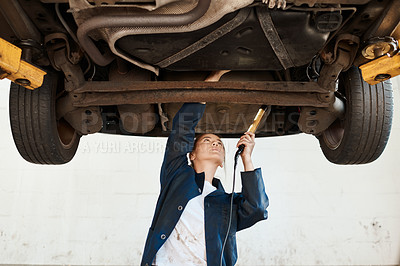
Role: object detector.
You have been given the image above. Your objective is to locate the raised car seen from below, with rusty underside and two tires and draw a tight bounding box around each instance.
[0,0,400,164]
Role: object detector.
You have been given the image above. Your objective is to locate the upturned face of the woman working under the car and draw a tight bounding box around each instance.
[190,134,225,167]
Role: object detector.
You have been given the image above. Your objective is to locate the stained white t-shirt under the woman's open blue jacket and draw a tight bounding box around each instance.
[153,180,216,266]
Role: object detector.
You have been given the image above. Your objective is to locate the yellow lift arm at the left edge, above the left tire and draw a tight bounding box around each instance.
[0,38,46,90]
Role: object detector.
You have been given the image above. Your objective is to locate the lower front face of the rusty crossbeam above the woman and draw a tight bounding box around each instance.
[73,89,329,107]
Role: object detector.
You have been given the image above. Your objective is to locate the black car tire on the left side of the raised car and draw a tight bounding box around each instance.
[9,73,80,164]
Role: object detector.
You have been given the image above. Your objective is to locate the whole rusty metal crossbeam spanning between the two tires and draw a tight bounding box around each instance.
[70,81,334,107]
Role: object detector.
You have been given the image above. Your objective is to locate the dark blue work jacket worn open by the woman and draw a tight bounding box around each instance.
[141,103,268,266]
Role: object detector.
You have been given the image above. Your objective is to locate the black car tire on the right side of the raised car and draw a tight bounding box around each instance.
[318,66,393,164]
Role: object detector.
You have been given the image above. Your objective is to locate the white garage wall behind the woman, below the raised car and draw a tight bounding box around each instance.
[0,79,400,265]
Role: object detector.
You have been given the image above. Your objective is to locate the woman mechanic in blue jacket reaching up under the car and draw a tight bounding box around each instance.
[141,103,268,266]
